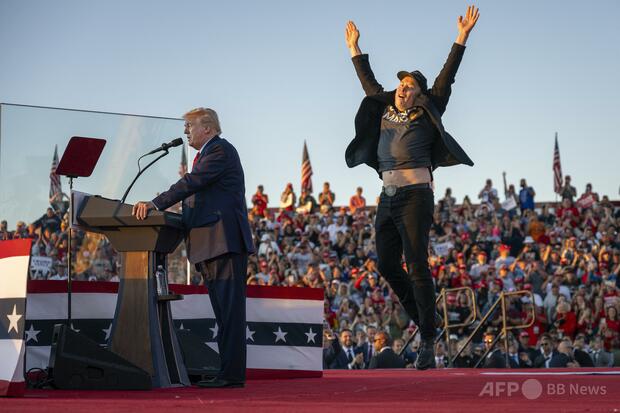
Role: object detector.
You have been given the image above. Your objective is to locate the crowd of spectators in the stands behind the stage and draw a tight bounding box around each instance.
[0,176,620,369]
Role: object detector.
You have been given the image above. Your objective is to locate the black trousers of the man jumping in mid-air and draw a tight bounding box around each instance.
[375,187,435,339]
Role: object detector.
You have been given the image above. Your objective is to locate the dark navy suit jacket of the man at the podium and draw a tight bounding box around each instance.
[152,136,255,264]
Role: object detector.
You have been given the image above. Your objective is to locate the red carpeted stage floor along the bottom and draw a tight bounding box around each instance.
[0,369,620,413]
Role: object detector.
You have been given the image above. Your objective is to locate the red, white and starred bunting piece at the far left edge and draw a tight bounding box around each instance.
[0,239,32,397]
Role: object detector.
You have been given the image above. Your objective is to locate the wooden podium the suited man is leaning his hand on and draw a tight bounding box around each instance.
[75,196,190,387]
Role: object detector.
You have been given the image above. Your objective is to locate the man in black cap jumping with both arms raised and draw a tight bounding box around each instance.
[345,6,480,370]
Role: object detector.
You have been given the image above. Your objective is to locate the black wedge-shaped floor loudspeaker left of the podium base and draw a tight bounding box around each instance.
[49,324,151,390]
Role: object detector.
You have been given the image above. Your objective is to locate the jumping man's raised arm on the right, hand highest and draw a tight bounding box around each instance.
[430,6,480,113]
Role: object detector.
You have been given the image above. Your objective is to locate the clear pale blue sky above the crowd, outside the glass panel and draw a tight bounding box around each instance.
[0,0,620,216]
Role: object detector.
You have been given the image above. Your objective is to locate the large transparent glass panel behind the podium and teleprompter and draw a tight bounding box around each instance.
[0,104,187,283]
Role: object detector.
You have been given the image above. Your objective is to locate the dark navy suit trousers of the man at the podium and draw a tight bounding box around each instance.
[196,253,248,382]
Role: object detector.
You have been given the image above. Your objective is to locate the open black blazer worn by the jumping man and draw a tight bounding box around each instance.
[345,43,474,172]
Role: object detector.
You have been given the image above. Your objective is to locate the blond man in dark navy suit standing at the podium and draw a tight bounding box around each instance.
[133,108,255,387]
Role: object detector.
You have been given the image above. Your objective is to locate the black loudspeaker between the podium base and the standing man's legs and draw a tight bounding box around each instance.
[177,330,220,382]
